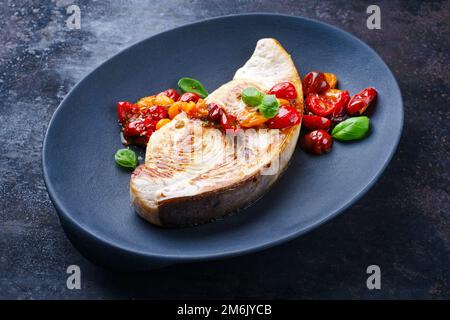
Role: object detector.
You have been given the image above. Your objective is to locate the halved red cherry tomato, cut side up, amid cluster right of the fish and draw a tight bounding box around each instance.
[306,89,350,117]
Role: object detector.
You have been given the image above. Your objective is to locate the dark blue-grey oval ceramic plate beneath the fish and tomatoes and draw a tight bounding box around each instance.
[43,14,403,270]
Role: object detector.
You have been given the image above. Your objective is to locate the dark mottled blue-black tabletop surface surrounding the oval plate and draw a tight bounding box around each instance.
[0,0,450,299]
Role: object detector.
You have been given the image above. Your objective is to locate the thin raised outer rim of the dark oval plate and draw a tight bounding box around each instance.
[41,12,404,262]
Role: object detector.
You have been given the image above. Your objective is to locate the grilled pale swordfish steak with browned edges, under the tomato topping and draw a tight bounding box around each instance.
[130,39,303,227]
